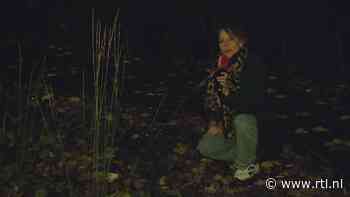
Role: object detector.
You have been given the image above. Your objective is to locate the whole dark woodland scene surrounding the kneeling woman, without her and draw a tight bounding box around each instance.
[0,0,350,197]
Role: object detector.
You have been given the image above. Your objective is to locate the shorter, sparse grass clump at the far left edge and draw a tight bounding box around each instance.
[0,42,74,196]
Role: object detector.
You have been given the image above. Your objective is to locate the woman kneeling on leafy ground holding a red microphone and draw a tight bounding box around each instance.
[197,25,266,180]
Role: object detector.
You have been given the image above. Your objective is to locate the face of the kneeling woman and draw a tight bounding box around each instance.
[219,30,239,56]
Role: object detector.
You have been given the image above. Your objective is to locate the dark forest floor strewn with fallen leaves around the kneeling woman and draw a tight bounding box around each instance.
[0,39,350,197]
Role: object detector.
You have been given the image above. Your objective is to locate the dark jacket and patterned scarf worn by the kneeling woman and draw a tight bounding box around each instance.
[205,48,266,137]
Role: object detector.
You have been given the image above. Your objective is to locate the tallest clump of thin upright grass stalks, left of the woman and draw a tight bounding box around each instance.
[87,10,123,196]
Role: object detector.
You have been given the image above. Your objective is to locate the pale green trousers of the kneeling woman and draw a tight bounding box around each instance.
[197,114,258,168]
